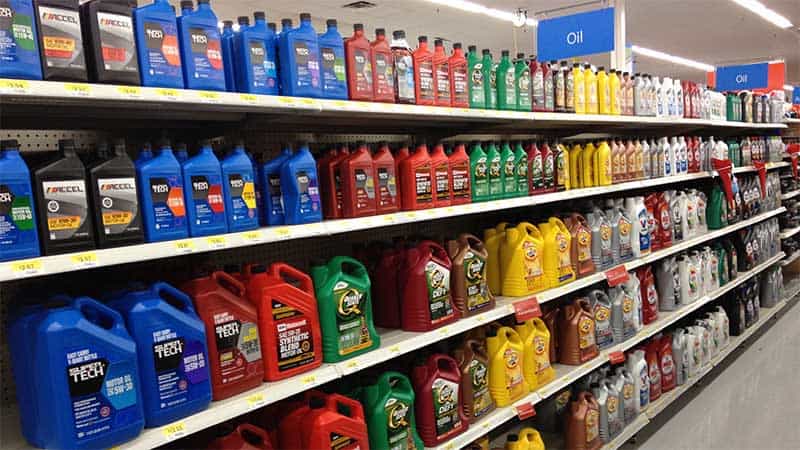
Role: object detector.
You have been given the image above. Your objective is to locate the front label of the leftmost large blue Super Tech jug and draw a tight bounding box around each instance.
[65,348,137,441]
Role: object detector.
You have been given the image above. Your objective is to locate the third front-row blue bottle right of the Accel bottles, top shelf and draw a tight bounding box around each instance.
[236,11,280,95]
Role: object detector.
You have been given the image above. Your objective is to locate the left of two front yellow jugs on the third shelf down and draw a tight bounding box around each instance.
[500,222,547,297]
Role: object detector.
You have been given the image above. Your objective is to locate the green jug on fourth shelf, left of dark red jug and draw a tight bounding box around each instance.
[360,372,423,449]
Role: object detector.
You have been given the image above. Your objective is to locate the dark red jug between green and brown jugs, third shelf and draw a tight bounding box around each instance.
[399,241,458,331]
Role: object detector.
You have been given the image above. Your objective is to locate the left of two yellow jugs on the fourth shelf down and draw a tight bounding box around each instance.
[486,327,530,407]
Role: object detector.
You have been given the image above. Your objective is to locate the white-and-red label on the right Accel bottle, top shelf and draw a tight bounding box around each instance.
[97,11,139,73]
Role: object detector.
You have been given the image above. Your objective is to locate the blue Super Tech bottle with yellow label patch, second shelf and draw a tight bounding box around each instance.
[221,144,258,232]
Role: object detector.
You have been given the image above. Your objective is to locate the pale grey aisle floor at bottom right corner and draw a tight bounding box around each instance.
[624,303,800,450]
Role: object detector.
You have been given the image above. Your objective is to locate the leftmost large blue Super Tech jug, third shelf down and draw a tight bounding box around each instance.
[26,297,144,449]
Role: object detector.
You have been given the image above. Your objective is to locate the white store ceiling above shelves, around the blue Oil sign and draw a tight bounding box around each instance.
[158,0,800,85]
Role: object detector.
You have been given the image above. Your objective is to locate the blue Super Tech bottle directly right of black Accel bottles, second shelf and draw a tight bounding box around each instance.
[136,141,189,242]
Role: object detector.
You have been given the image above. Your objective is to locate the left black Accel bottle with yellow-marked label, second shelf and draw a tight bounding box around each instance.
[32,140,95,255]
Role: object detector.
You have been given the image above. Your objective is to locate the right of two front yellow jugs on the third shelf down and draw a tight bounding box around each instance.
[539,217,575,288]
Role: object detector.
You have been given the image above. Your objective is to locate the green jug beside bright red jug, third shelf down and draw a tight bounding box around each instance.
[311,256,381,363]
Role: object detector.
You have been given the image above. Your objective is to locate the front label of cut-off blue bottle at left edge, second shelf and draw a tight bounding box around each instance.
[0,183,36,248]
